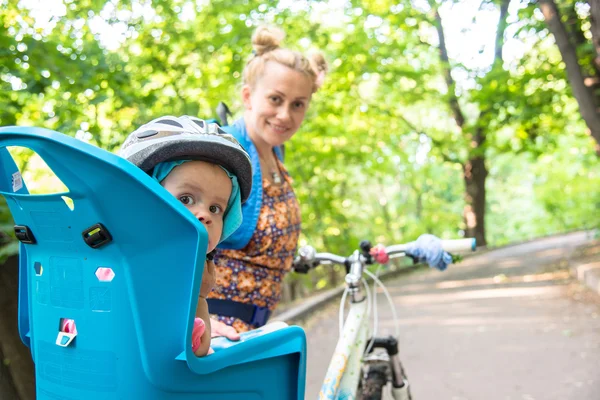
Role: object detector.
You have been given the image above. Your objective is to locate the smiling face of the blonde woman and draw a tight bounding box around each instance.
[242,61,313,147]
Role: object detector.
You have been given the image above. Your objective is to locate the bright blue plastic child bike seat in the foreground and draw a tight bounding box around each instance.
[0,127,306,400]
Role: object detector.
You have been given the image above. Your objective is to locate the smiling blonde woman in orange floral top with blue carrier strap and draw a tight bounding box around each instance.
[209,27,327,339]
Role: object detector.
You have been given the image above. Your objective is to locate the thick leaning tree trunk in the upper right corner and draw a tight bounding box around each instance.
[539,0,600,156]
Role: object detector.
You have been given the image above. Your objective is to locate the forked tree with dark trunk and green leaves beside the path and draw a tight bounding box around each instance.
[418,0,584,244]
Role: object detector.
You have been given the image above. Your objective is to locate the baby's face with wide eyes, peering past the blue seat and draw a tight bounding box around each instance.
[162,161,231,252]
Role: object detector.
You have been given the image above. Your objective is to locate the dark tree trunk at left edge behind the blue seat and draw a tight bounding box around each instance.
[0,256,35,400]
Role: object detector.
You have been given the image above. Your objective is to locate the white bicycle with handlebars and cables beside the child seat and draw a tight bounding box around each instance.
[294,239,475,400]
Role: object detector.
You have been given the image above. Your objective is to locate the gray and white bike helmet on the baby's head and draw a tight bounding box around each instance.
[119,115,252,203]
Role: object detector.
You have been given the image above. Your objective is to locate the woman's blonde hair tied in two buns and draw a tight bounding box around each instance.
[242,26,328,93]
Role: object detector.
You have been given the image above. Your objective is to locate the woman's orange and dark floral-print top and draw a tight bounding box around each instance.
[208,161,301,332]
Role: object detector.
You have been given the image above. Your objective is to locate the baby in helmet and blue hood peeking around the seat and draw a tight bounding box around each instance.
[61,116,252,356]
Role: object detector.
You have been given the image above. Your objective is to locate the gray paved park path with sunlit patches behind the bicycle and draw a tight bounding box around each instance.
[305,233,600,400]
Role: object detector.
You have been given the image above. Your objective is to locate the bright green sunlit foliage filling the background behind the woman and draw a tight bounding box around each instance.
[0,0,600,294]
